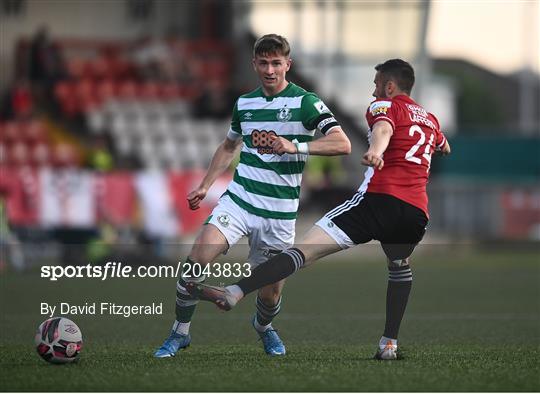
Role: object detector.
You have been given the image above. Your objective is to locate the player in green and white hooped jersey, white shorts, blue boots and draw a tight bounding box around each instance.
[155,34,351,358]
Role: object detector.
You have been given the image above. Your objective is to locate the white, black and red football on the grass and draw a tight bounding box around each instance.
[35,317,83,364]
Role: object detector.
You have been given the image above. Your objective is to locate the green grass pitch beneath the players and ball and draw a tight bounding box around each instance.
[0,247,540,392]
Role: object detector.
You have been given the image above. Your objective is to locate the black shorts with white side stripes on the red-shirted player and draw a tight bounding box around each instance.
[319,192,428,261]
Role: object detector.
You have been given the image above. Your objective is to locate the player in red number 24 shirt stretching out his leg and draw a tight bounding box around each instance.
[189,59,450,360]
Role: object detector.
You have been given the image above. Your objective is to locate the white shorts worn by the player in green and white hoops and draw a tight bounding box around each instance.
[206,195,296,268]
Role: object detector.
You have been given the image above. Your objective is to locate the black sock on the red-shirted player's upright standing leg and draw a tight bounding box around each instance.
[383,265,412,339]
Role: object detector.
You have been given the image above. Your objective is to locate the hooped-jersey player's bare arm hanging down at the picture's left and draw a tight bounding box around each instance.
[187,138,242,210]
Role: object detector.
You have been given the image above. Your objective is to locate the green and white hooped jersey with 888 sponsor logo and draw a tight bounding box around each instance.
[226,83,339,220]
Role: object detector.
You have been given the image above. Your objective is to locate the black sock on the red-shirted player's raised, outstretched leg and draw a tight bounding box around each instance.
[236,248,305,295]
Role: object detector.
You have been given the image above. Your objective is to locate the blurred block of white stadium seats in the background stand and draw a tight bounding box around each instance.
[99,101,229,169]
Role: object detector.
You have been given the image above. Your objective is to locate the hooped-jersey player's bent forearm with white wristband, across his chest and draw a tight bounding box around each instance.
[272,127,351,156]
